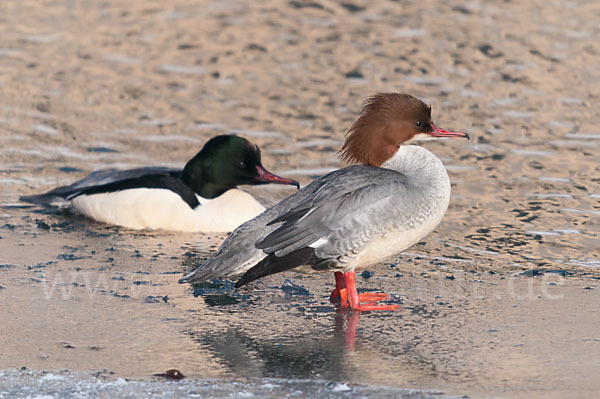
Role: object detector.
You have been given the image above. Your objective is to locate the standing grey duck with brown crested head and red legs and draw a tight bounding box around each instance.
[180,93,468,311]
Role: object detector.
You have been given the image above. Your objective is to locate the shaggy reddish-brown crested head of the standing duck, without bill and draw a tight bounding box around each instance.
[339,93,433,166]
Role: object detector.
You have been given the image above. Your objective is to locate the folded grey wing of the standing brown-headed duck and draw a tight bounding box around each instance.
[256,169,408,264]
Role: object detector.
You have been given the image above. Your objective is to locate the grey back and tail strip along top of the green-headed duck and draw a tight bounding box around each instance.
[19,166,181,205]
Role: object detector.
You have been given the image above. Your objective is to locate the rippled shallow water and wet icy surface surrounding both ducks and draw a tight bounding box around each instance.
[0,0,600,397]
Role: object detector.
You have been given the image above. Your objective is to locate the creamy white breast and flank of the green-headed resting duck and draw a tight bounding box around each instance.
[72,188,265,232]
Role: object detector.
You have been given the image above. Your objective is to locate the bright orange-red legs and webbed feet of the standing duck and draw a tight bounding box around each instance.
[330,272,399,311]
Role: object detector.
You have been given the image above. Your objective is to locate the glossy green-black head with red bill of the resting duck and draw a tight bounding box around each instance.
[182,135,300,198]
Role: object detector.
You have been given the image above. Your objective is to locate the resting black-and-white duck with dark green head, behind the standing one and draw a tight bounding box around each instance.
[21,135,299,232]
